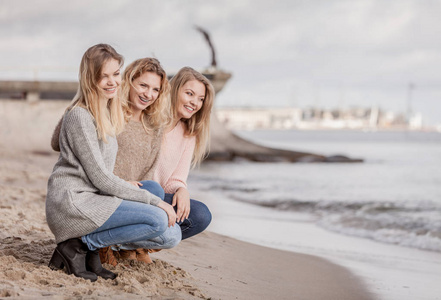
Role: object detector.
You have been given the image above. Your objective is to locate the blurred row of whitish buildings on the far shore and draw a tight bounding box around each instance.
[216,107,423,130]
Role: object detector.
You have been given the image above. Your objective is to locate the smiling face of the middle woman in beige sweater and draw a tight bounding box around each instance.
[129,72,161,113]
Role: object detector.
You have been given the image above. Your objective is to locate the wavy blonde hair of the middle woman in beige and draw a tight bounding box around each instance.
[121,57,171,132]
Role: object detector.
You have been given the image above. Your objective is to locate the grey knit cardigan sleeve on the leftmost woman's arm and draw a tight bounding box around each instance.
[61,108,161,205]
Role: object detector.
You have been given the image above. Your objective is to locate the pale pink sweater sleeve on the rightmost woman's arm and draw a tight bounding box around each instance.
[164,137,196,193]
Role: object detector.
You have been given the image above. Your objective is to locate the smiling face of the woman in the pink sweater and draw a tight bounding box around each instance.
[177,80,205,119]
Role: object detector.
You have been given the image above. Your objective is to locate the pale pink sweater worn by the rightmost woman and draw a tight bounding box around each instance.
[153,121,196,194]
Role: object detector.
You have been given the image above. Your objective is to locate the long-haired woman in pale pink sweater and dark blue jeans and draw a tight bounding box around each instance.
[149,67,214,239]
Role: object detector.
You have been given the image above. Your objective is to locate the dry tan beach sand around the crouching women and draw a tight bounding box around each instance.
[0,100,373,299]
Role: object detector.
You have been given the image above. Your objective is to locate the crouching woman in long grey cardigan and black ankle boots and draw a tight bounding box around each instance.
[46,44,181,281]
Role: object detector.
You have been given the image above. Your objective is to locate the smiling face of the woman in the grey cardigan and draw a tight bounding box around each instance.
[98,58,121,99]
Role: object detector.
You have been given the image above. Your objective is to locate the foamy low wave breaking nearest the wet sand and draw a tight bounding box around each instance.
[223,194,441,252]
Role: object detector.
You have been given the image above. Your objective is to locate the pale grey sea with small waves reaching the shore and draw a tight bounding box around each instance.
[189,130,441,252]
